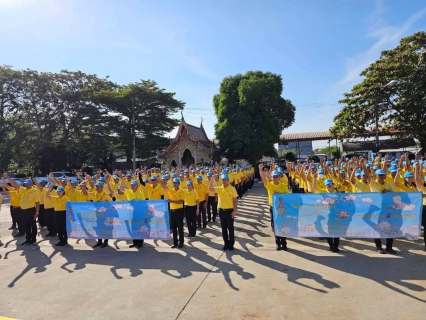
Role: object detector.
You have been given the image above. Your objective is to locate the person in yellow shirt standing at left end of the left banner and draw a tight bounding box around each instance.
[46,186,69,247]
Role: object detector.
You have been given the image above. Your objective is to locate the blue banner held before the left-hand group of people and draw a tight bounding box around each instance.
[67,200,170,240]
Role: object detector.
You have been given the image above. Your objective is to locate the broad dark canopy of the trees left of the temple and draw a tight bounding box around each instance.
[0,66,184,174]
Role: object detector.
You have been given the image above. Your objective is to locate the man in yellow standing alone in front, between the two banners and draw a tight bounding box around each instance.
[209,174,238,251]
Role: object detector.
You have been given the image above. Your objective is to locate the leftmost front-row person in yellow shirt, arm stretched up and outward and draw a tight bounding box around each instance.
[6,174,40,245]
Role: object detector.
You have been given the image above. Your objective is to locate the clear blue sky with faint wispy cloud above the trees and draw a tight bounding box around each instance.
[0,0,426,147]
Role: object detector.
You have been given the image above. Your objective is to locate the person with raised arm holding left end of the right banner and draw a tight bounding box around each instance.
[259,164,289,251]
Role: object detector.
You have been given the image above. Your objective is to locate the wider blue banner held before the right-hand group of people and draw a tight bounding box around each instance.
[273,192,423,239]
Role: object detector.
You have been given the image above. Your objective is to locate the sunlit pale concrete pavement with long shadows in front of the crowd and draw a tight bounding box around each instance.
[0,185,426,320]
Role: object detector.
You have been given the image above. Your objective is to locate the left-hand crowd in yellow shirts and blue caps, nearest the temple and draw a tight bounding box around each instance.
[0,165,254,250]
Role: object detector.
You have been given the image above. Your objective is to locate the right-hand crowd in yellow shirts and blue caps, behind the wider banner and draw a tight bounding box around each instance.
[259,153,426,254]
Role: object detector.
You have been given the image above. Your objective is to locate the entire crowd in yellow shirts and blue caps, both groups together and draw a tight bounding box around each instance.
[0,154,426,254]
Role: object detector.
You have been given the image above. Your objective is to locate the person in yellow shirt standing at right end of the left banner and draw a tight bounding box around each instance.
[160,178,186,248]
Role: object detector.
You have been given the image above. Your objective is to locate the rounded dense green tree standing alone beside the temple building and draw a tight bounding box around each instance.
[213,71,295,163]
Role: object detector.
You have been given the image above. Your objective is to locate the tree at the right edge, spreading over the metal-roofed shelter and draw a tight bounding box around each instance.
[330,31,426,151]
